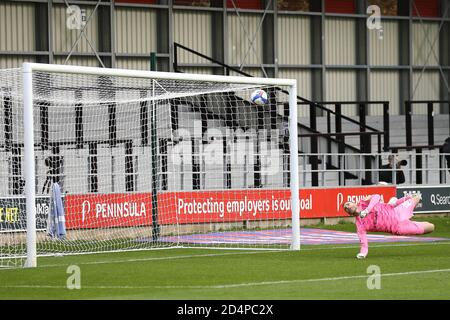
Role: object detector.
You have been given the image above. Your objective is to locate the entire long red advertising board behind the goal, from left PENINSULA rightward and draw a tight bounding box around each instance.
[65,186,396,229]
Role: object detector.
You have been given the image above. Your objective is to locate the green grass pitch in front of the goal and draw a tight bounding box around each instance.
[0,217,450,300]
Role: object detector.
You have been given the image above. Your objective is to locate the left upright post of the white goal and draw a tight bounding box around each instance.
[22,63,37,268]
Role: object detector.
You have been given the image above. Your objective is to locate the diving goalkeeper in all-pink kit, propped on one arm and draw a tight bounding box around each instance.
[344,194,434,259]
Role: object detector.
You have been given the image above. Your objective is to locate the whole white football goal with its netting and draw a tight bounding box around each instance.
[0,63,300,267]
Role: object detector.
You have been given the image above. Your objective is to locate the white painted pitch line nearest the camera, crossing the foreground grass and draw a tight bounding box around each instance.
[0,269,450,290]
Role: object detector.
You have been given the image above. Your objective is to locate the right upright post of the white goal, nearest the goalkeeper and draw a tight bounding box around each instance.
[289,83,300,250]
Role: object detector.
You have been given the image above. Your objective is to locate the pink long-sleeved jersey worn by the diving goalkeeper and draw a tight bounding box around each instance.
[356,194,409,255]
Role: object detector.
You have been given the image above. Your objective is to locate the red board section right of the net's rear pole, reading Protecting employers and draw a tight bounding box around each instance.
[164,186,396,224]
